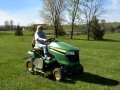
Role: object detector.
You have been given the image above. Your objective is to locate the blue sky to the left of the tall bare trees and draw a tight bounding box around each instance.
[0,0,43,25]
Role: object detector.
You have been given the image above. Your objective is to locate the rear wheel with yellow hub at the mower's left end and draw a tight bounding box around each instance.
[26,58,35,75]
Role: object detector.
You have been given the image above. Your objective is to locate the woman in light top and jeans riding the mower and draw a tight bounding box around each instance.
[34,25,50,59]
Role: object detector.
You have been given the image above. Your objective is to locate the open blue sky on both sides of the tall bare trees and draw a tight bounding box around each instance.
[0,0,120,25]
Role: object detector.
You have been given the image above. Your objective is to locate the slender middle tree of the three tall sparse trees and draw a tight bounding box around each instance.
[67,0,80,39]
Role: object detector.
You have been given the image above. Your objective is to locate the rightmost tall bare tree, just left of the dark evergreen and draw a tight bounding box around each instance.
[82,0,106,40]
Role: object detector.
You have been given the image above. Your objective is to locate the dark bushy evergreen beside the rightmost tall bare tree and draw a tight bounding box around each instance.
[91,17,105,40]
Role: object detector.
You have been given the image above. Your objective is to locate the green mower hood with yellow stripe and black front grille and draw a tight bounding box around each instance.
[48,41,80,67]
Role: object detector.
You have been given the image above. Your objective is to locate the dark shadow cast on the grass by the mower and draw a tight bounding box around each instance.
[64,72,119,86]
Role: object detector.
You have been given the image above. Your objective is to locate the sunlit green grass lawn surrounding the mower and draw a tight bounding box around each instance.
[0,32,120,90]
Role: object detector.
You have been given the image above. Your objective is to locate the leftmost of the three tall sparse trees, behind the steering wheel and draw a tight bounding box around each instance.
[40,0,65,37]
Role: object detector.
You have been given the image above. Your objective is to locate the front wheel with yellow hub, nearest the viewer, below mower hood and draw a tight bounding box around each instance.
[53,68,63,82]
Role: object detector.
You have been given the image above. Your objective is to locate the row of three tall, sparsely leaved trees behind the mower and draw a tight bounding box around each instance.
[40,0,106,40]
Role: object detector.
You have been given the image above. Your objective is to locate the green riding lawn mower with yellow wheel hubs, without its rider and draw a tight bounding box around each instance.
[26,38,83,81]
